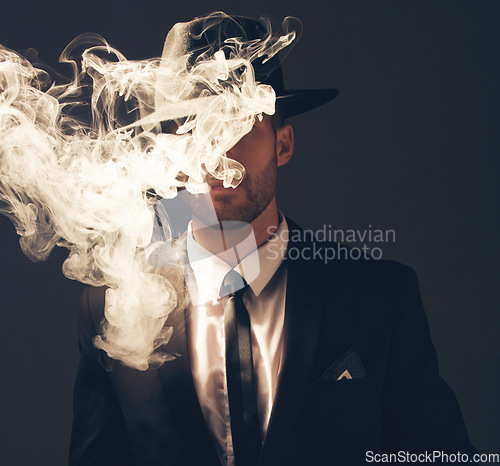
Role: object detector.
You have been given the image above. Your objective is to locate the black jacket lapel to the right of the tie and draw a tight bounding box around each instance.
[260,218,322,466]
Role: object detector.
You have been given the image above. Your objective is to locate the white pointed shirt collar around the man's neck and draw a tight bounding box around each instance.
[187,212,288,302]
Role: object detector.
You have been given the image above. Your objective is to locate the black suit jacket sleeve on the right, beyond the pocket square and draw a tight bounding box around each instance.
[382,267,477,456]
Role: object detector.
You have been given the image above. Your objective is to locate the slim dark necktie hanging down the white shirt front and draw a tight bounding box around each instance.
[221,270,262,466]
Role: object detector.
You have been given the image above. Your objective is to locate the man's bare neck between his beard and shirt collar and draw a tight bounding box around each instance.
[191,198,279,254]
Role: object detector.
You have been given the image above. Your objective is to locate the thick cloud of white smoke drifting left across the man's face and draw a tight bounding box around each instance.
[0,13,295,370]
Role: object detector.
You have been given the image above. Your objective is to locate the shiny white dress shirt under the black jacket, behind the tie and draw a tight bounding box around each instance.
[187,214,288,466]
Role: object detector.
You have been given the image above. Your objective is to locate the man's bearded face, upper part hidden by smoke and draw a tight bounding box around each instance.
[186,115,286,225]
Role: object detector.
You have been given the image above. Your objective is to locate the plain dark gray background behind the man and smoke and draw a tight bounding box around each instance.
[0,0,500,466]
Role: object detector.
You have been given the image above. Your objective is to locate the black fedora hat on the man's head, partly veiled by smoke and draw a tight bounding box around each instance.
[162,12,339,119]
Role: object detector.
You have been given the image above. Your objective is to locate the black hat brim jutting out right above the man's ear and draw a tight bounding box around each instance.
[276,89,339,118]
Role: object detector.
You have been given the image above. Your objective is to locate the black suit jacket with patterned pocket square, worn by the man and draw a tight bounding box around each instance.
[70,219,476,466]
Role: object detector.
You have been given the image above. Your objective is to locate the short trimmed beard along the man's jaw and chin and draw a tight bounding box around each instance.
[184,154,278,226]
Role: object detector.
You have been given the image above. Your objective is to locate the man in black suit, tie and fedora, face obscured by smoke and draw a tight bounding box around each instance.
[70,12,475,466]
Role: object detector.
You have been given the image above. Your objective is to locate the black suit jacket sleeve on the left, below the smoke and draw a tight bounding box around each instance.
[69,288,135,466]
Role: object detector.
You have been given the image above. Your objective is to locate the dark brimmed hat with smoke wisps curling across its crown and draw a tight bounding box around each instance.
[162,12,338,118]
